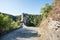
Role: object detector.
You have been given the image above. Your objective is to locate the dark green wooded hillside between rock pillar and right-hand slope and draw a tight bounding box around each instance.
[28,15,41,26]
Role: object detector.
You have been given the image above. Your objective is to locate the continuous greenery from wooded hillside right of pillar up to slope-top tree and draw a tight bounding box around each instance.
[29,3,52,26]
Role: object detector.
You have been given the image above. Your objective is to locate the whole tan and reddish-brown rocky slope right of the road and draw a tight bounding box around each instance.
[40,0,60,40]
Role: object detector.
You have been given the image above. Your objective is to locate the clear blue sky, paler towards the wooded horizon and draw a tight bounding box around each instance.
[0,0,53,15]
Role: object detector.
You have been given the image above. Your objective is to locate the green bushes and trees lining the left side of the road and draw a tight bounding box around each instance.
[0,12,20,34]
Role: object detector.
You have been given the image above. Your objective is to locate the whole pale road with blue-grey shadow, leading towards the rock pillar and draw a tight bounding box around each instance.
[0,27,38,40]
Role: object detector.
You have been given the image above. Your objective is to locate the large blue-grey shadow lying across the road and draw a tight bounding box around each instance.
[0,28,37,40]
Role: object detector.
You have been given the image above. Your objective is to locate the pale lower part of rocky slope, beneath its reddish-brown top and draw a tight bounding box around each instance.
[40,17,60,40]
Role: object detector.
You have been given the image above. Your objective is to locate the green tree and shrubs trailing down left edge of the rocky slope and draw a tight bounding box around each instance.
[38,3,52,25]
